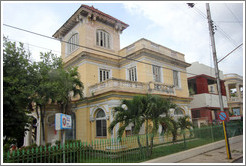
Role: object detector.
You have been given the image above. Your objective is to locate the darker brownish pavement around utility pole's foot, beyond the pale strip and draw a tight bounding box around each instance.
[178,142,243,163]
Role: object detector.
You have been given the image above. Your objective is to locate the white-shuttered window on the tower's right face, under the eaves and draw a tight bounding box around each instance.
[96,30,110,48]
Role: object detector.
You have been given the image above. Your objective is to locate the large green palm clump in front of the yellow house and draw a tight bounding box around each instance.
[109,94,176,156]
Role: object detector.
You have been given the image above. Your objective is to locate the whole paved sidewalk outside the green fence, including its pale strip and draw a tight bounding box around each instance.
[144,135,244,163]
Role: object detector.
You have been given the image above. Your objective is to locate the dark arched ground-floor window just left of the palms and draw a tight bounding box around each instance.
[96,109,107,137]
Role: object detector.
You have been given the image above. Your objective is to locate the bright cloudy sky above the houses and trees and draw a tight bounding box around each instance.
[1,1,245,75]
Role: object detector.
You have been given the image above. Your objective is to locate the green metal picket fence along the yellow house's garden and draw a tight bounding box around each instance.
[3,122,243,163]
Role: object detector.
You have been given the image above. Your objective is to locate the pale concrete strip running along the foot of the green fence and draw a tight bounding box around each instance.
[142,135,243,163]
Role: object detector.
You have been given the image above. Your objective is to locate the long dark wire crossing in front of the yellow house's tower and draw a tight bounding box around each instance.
[3,24,200,76]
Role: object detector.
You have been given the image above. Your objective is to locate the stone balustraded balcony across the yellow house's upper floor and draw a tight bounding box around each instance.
[88,78,176,97]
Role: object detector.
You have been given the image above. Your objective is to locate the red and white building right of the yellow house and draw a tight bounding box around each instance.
[188,64,229,127]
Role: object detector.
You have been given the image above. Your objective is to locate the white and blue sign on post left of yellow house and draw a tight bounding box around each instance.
[55,113,72,130]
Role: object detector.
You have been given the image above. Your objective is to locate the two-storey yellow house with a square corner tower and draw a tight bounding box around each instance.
[49,5,191,141]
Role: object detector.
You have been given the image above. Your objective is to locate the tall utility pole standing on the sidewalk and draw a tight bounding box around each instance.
[206,3,231,159]
